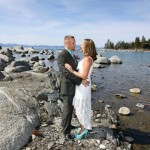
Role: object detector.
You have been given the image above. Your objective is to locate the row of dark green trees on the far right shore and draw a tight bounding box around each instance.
[104,36,150,50]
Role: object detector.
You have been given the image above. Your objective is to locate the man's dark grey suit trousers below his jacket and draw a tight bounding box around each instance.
[61,95,74,134]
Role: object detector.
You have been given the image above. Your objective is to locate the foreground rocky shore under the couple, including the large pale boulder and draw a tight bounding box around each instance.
[0,71,132,150]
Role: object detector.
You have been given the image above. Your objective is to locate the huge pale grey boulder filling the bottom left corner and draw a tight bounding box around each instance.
[0,87,39,150]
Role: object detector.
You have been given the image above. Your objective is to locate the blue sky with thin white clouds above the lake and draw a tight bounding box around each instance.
[0,0,150,47]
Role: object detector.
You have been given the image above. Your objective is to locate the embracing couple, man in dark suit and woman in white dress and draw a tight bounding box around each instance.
[58,35,97,139]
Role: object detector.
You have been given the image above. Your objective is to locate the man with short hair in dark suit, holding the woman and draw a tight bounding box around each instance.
[57,35,89,139]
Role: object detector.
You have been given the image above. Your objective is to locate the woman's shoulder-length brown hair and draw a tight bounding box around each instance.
[84,39,97,61]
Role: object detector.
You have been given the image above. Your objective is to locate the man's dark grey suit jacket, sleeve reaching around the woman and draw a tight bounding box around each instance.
[57,49,82,95]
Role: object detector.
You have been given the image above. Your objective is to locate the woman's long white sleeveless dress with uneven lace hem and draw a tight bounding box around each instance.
[73,58,93,130]
